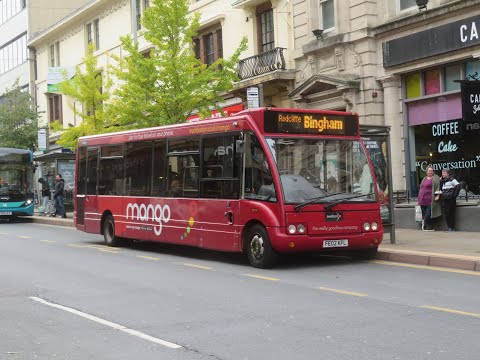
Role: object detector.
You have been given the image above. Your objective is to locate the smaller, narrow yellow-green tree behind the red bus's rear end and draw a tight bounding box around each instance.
[52,46,111,149]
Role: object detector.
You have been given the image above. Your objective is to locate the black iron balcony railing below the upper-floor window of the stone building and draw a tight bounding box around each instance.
[238,48,286,80]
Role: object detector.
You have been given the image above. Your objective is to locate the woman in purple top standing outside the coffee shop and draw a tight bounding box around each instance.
[418,165,442,231]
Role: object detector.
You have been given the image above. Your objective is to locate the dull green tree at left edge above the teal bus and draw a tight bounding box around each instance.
[0,80,38,150]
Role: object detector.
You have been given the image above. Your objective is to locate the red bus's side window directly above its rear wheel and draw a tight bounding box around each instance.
[98,145,124,195]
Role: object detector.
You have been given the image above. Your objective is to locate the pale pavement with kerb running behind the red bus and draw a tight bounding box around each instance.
[25,212,480,272]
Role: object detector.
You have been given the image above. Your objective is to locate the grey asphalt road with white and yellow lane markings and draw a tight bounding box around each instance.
[0,223,480,360]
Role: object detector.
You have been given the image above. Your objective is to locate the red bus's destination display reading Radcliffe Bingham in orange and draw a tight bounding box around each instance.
[265,110,358,136]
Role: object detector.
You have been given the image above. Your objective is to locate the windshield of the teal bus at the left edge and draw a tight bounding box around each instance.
[0,163,32,196]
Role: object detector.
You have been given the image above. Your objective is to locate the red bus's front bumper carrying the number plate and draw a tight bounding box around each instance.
[267,227,383,253]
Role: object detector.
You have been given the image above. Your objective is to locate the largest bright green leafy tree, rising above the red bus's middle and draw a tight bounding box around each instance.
[109,0,247,129]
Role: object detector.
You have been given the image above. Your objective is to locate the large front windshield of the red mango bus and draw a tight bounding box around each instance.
[266,138,376,204]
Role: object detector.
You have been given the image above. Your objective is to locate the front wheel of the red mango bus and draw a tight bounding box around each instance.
[246,224,278,269]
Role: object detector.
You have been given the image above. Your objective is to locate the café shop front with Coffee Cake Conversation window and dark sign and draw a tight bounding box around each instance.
[383,14,480,197]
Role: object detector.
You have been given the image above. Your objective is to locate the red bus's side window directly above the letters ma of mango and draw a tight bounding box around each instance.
[124,142,153,196]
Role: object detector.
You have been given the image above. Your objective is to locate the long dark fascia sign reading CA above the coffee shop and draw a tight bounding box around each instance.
[382,16,480,68]
